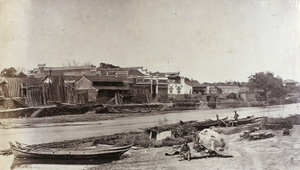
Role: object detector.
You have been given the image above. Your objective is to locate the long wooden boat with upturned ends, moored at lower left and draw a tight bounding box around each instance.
[9,142,132,160]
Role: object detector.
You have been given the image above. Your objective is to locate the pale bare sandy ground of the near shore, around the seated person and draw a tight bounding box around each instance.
[6,125,300,170]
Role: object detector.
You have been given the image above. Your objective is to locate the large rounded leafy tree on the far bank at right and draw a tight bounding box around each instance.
[248,72,286,99]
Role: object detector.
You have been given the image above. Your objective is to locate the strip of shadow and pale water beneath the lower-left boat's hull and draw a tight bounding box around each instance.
[10,158,116,170]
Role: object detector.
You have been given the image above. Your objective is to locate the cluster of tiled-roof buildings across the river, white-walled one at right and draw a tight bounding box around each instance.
[24,63,205,103]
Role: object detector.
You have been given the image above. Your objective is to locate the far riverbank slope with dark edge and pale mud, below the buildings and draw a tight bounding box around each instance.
[0,103,180,129]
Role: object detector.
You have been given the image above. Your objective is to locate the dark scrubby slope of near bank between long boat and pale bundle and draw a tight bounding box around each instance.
[31,121,195,148]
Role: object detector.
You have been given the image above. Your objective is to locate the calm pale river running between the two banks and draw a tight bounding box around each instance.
[0,104,300,169]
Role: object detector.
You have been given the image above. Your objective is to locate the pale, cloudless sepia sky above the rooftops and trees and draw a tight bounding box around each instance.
[0,0,300,83]
